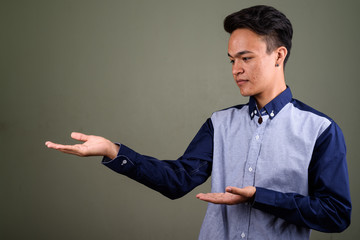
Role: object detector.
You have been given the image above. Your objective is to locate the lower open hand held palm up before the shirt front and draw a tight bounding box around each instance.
[196,186,256,205]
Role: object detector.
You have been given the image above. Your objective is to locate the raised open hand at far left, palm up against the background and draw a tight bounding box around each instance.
[45,132,120,159]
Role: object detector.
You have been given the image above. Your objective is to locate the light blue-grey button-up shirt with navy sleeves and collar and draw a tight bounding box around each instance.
[103,88,351,239]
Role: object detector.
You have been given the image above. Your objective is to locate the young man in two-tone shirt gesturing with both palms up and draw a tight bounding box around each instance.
[46,6,351,239]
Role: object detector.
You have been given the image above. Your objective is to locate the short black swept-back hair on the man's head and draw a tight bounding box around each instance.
[224,5,293,66]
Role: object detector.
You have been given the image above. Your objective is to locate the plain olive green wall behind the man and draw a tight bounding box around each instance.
[0,0,360,240]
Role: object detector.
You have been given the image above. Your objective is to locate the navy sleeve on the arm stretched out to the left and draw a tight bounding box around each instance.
[102,118,214,199]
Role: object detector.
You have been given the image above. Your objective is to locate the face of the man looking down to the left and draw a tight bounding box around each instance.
[228,29,285,99]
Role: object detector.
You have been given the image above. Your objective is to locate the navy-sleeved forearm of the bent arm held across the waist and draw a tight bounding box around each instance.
[253,187,351,232]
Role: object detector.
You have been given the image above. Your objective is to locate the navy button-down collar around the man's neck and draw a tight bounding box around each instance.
[249,86,292,119]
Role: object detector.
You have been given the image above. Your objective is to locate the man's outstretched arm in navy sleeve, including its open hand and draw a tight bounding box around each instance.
[45,119,214,199]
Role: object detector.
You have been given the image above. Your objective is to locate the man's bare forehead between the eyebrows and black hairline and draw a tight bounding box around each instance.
[228,28,266,56]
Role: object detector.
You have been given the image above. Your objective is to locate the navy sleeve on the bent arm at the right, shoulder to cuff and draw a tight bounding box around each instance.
[253,122,352,232]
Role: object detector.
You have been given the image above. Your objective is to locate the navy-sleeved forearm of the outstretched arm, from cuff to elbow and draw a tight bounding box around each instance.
[102,145,211,199]
